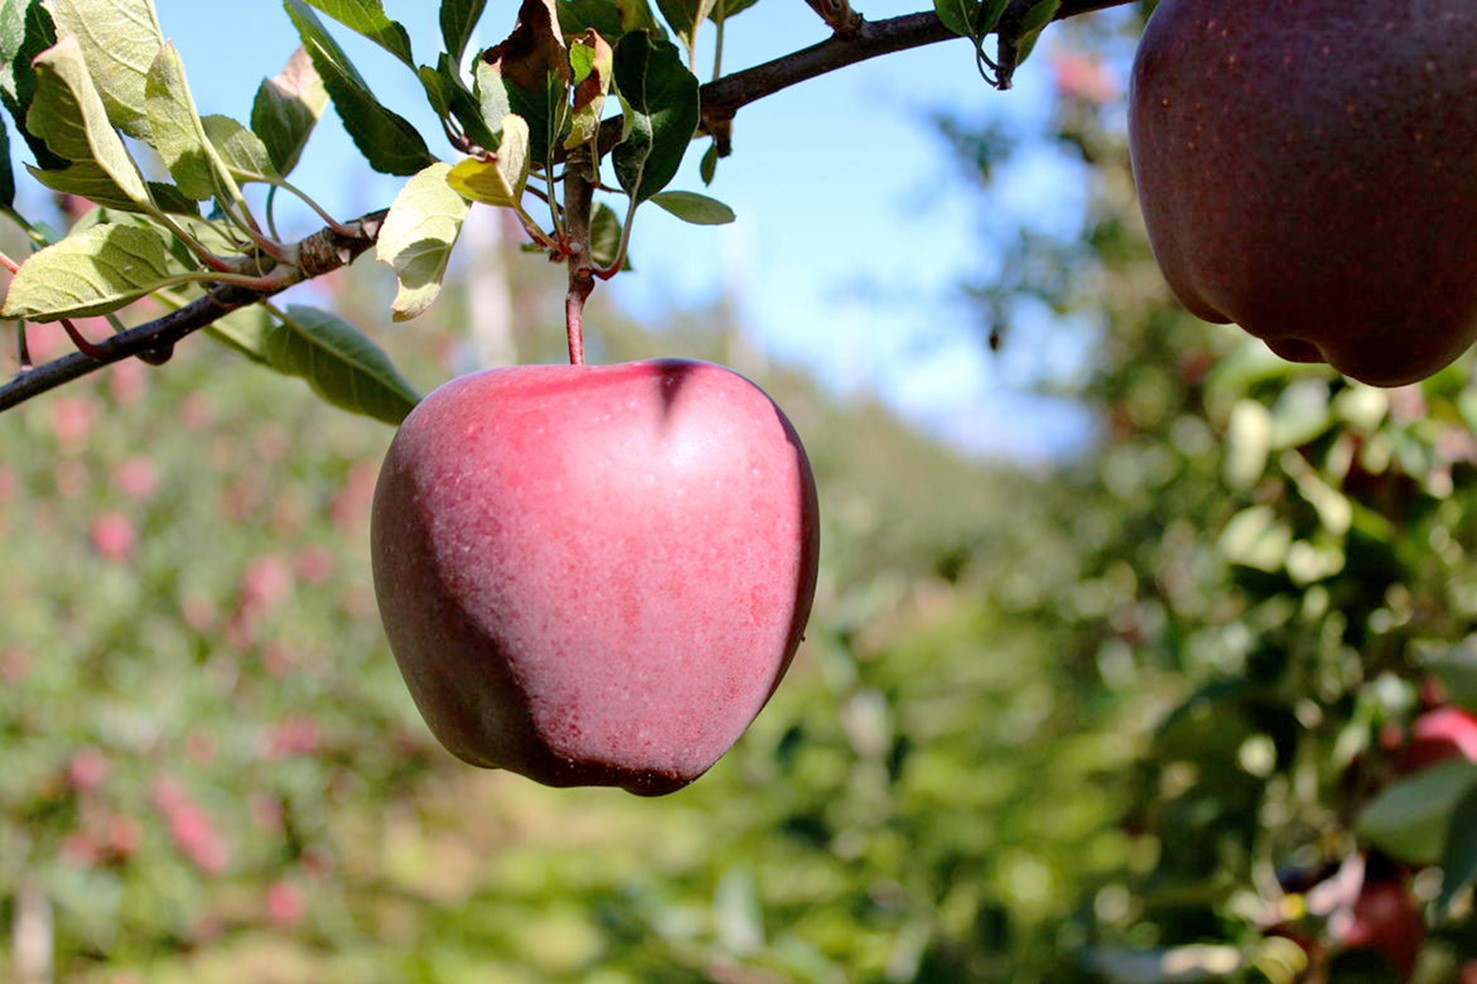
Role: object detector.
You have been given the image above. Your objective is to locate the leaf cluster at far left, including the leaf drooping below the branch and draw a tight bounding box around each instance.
[0,0,418,423]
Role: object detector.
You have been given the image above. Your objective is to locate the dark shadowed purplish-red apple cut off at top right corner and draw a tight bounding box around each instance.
[1128,0,1477,386]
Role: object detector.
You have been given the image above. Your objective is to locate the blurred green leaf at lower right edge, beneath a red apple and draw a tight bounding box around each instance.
[1354,761,1477,864]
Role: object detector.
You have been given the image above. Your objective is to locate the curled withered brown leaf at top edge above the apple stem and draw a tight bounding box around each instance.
[477,0,570,165]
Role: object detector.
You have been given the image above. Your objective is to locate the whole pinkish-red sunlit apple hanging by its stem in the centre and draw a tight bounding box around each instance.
[371,359,820,795]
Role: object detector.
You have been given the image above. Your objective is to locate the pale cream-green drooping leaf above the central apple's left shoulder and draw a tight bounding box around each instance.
[375,161,471,321]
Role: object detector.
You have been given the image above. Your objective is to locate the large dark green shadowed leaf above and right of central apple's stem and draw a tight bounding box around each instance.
[611,33,699,205]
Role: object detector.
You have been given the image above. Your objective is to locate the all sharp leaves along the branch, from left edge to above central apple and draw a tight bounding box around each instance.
[0,0,750,423]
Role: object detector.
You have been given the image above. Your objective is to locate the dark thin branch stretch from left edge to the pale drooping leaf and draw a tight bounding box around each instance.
[0,210,385,411]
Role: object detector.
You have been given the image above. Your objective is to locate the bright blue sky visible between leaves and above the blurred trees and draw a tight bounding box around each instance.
[146,0,1081,457]
